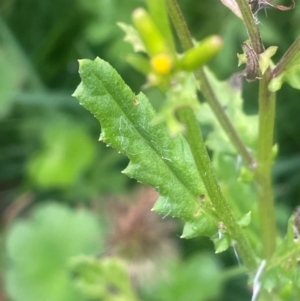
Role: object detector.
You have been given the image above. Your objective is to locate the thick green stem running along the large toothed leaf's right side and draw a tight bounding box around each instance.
[178,107,256,269]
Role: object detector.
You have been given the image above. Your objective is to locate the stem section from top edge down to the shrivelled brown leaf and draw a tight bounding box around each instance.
[236,0,264,54]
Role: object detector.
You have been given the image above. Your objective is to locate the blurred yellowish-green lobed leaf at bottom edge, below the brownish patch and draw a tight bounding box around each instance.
[69,256,136,301]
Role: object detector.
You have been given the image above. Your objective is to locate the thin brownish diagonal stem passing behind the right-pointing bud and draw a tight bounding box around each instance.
[167,0,255,168]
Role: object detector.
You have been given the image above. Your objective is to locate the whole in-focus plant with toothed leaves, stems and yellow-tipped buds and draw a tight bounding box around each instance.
[74,0,300,301]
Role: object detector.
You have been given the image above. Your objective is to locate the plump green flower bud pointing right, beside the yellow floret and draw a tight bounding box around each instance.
[178,35,223,71]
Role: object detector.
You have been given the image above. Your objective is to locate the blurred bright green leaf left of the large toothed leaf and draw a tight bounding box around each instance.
[28,120,95,188]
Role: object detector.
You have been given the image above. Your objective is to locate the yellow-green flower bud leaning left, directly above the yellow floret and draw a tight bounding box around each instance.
[132,8,169,56]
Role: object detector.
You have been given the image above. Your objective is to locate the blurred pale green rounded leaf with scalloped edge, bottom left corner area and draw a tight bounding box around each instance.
[6,204,102,301]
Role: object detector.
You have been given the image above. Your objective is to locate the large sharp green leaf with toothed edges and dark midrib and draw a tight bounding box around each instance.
[74,58,213,230]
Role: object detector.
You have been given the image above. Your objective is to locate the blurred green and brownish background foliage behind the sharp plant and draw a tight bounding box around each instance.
[0,0,300,301]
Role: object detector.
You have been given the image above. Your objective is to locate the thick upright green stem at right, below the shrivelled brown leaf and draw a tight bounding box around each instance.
[255,70,276,259]
